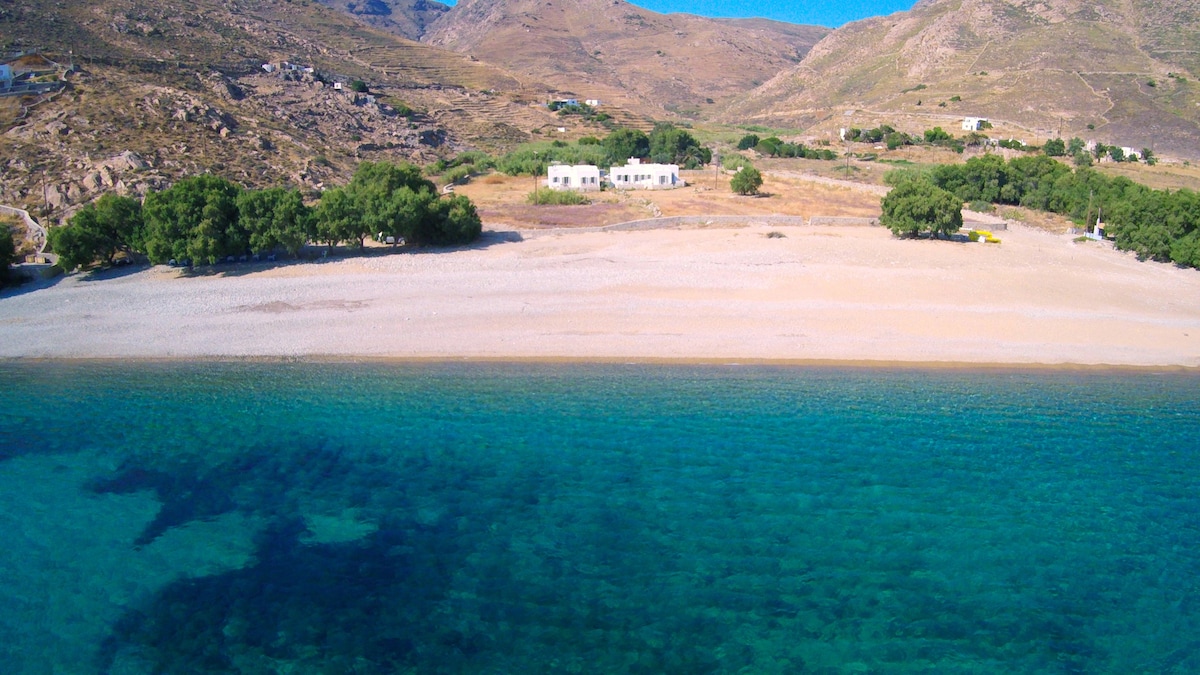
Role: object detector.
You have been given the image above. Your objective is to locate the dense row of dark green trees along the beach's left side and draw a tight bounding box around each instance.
[49,162,482,270]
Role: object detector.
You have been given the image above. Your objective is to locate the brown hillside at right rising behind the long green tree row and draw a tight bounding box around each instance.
[721,0,1200,157]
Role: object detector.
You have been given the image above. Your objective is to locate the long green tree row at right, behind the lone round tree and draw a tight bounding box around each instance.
[886,155,1200,268]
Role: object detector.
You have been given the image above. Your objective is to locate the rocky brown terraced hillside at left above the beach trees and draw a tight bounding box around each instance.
[0,0,609,221]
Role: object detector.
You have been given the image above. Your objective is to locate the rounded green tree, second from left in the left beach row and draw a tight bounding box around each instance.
[143,174,242,264]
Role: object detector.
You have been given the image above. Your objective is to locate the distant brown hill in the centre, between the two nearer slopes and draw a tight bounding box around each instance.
[424,0,828,117]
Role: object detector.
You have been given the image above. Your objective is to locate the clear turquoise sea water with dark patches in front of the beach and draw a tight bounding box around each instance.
[0,364,1200,674]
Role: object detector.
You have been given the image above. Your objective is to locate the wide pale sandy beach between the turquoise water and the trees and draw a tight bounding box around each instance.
[0,225,1200,368]
